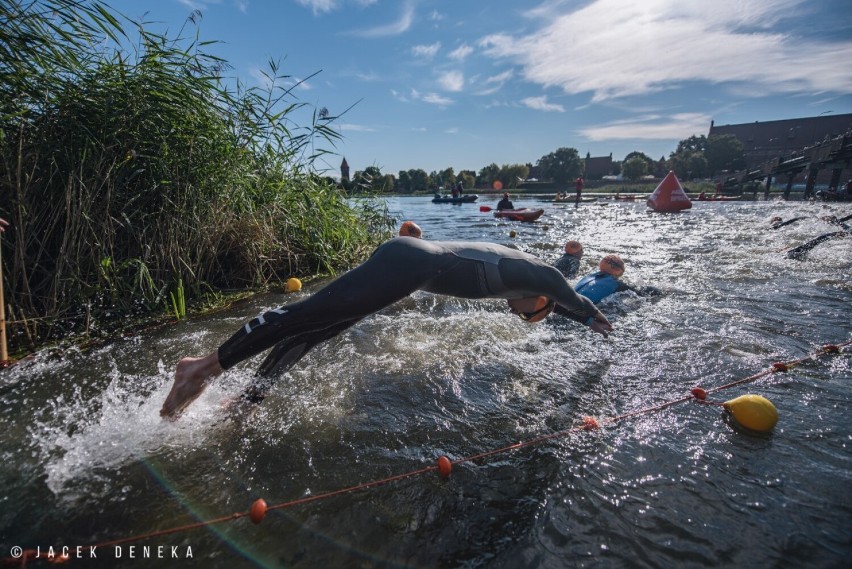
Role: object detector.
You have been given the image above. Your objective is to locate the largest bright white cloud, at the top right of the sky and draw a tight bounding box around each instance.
[479,0,852,101]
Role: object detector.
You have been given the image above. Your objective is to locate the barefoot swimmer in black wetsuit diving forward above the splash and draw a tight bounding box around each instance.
[160,237,612,419]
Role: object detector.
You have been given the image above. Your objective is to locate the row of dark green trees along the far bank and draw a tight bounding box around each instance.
[341,134,745,193]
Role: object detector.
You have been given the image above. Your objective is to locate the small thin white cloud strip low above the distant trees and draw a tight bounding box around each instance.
[578,113,711,141]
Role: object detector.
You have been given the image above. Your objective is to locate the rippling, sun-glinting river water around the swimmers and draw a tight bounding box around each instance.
[0,193,852,568]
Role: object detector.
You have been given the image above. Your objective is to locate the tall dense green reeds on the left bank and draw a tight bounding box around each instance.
[0,0,394,358]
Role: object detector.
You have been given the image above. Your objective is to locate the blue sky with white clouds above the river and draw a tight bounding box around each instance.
[106,0,852,177]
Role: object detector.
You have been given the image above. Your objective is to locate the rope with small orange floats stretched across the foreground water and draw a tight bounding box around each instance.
[2,340,852,567]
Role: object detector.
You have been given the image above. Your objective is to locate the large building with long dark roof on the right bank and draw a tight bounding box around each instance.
[708,114,852,169]
